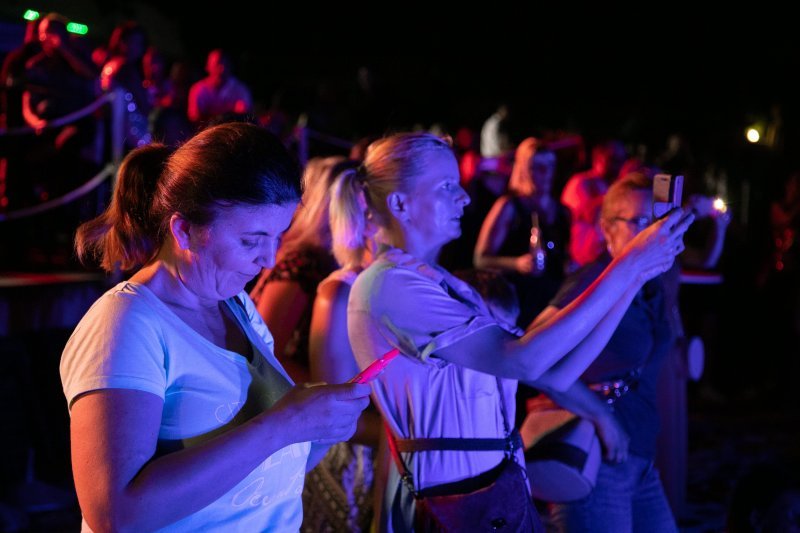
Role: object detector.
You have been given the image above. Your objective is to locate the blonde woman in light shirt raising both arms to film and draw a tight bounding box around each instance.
[332,133,692,531]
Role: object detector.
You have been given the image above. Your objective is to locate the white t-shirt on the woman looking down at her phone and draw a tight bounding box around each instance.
[61,282,311,532]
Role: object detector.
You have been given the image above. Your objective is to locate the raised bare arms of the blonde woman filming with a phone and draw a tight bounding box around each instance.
[435,210,694,390]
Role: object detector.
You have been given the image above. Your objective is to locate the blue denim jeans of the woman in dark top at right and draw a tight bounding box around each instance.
[547,455,678,533]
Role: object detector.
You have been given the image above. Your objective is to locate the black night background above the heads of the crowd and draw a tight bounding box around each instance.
[0,0,800,286]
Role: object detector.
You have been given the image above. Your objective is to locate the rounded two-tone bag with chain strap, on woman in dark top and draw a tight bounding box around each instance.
[520,372,649,503]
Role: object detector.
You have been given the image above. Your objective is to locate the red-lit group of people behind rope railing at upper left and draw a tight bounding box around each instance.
[0,13,255,210]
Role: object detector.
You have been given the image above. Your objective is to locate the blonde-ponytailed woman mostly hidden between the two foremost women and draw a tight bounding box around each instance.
[303,168,381,533]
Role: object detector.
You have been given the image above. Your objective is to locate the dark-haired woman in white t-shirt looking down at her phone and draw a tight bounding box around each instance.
[61,123,369,531]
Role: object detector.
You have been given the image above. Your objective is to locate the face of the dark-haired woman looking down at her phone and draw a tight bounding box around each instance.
[184,203,297,301]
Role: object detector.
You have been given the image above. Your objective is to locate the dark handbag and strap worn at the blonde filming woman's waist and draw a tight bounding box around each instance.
[385,380,544,533]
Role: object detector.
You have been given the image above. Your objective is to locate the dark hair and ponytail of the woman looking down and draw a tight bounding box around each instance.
[75,122,302,272]
